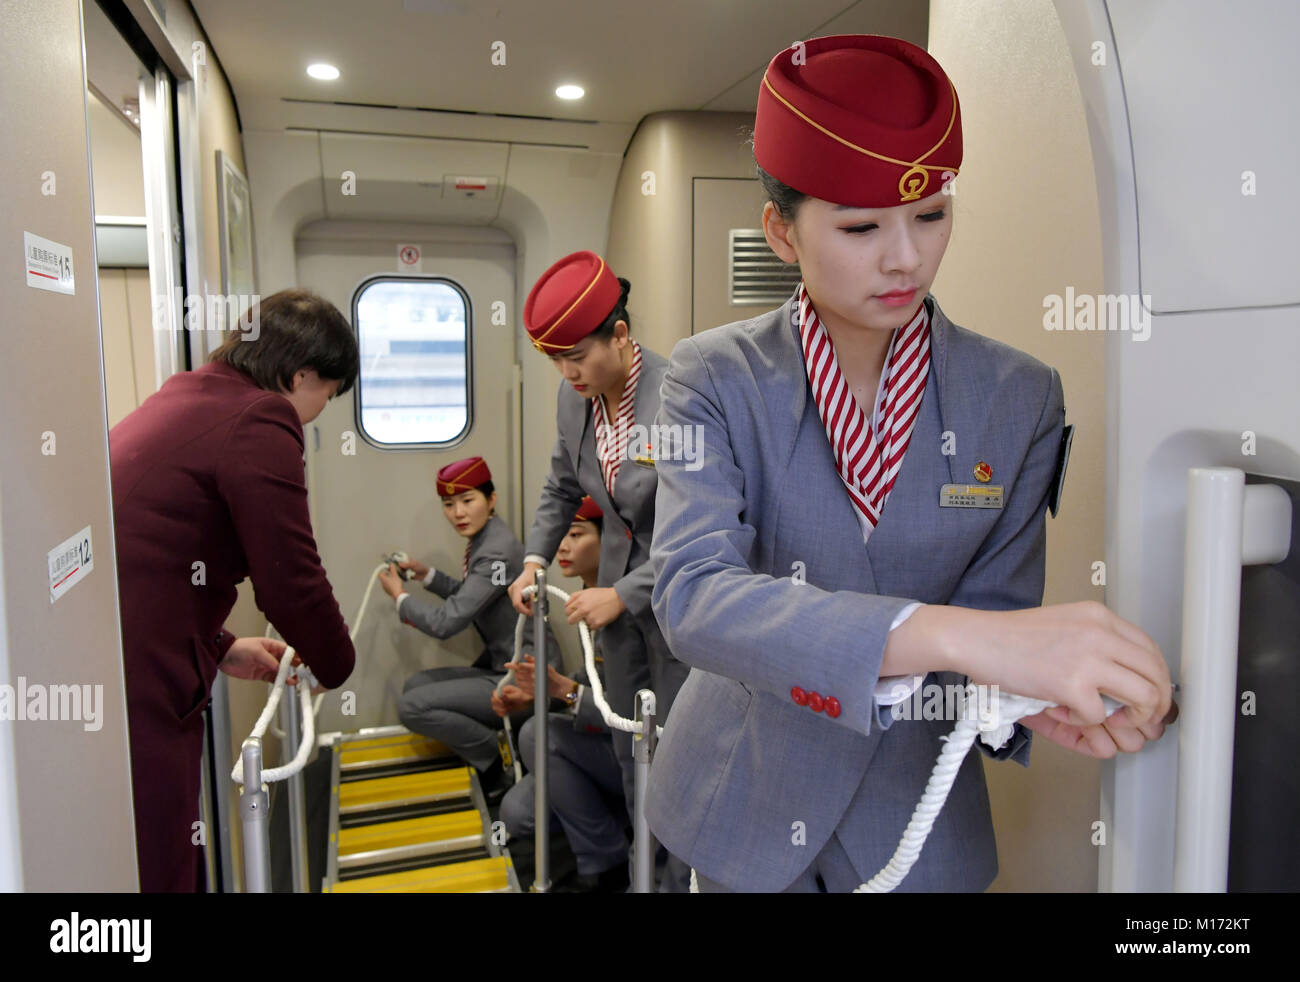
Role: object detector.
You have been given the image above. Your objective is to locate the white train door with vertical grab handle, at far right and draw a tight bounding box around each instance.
[1057,0,1300,891]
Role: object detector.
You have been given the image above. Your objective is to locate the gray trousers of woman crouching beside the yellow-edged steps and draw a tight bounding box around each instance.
[400,666,502,771]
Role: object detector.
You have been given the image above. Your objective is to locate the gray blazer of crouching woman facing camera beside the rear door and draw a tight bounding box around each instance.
[402,515,533,672]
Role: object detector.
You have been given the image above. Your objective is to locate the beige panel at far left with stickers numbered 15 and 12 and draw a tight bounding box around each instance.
[0,0,138,891]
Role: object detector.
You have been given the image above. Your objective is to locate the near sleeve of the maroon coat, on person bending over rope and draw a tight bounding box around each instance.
[216,394,356,688]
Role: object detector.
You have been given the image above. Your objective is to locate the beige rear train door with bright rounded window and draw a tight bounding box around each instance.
[296,221,521,731]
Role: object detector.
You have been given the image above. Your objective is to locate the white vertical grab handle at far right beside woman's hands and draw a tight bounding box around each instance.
[1174,467,1291,894]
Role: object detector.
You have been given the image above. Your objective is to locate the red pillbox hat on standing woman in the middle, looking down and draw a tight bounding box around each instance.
[524,250,623,355]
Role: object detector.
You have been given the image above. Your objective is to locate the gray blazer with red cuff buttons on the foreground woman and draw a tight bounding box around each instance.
[649,297,1065,891]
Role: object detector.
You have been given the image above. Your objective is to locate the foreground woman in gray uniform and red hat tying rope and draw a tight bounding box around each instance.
[647,35,1171,892]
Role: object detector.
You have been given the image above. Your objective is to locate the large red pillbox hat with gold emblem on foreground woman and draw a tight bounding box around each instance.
[754,34,962,208]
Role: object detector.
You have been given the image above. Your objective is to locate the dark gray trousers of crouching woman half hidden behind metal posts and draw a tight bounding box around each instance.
[501,713,628,875]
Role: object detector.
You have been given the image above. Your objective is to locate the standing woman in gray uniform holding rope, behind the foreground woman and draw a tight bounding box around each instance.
[510,251,689,891]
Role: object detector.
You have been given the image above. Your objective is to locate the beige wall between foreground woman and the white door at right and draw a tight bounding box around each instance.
[930,0,1105,891]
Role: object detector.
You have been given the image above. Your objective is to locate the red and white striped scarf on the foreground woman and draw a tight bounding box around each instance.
[794,282,930,528]
